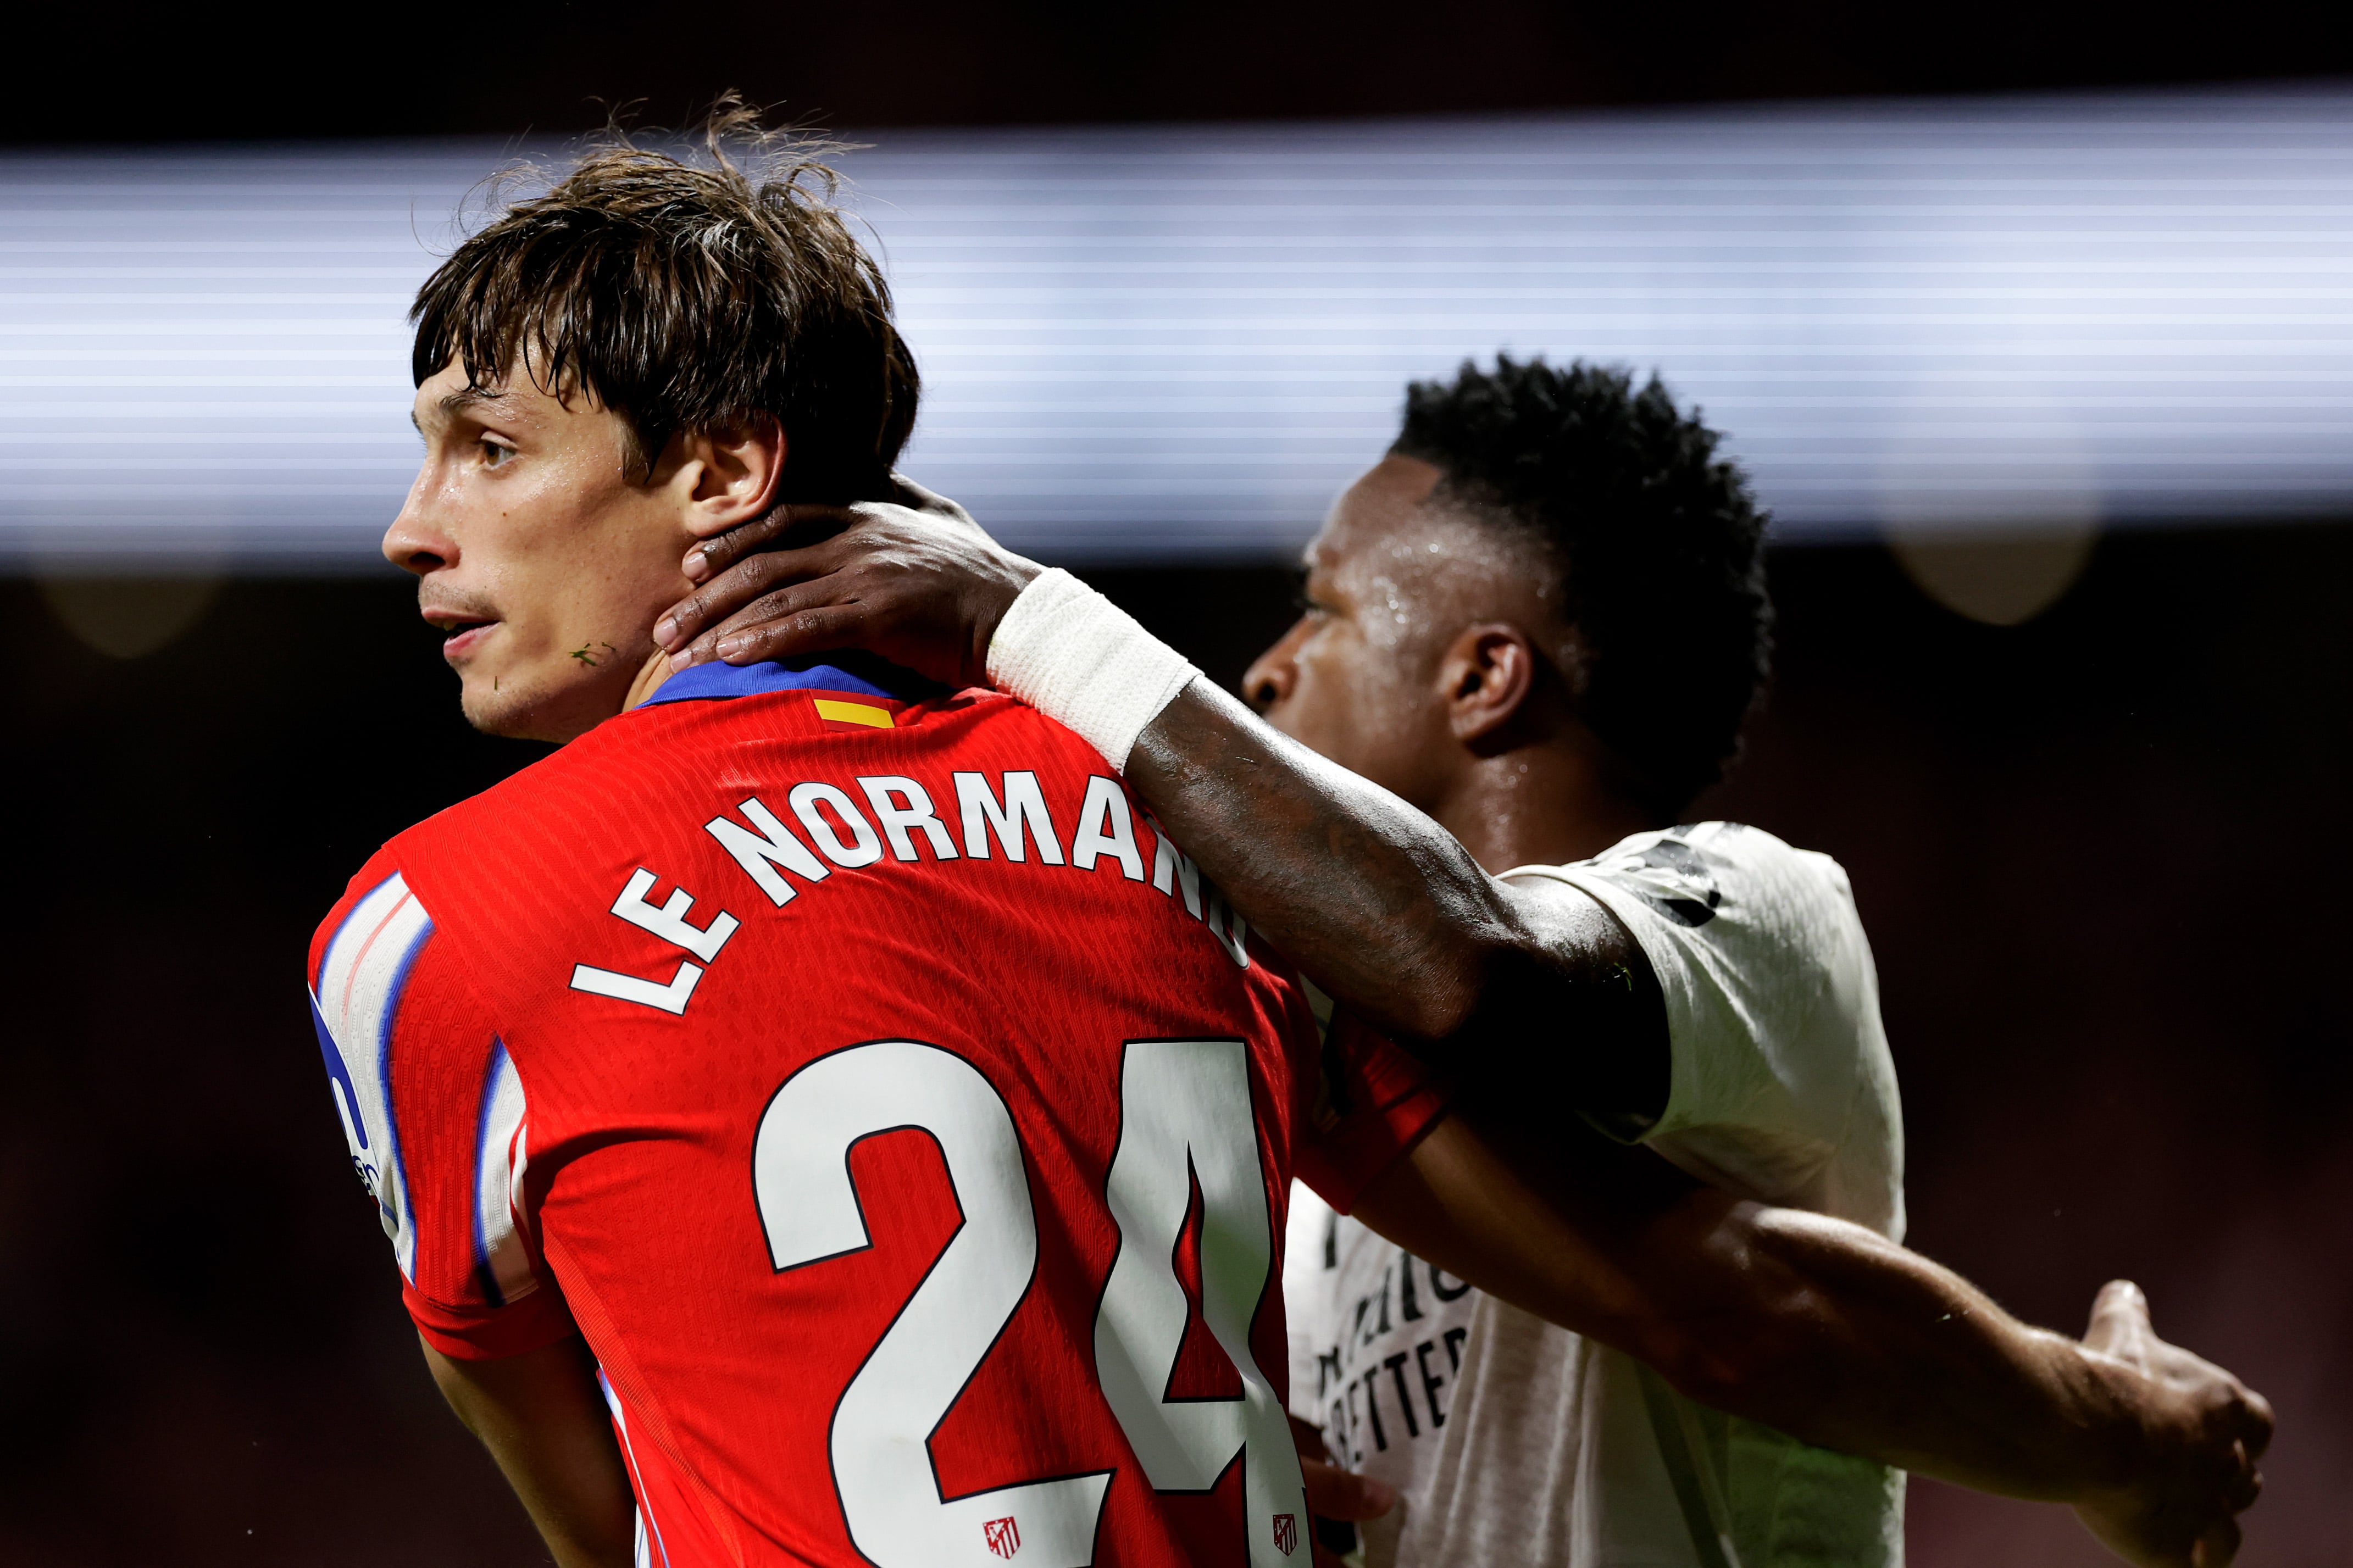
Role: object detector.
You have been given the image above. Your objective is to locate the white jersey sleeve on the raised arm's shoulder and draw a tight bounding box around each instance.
[1506,823,1894,1201]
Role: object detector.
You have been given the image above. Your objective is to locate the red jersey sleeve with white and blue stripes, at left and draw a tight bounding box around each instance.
[310,856,572,1361]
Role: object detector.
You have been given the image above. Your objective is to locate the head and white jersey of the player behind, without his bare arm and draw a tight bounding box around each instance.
[1245,360,1904,1568]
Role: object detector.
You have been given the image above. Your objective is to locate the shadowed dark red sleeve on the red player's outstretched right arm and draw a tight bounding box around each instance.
[1292,985,1447,1213]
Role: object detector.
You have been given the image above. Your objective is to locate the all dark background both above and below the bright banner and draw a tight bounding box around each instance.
[0,0,2353,1568]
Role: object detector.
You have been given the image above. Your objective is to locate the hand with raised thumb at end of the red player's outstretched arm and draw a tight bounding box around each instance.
[2075,1279,2271,1568]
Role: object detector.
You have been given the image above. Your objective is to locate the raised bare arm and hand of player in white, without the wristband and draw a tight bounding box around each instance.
[654,505,1666,1091]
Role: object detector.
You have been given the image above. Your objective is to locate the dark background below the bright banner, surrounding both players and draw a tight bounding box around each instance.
[0,524,2353,1568]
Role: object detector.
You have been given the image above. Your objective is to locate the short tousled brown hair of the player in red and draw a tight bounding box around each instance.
[409,101,920,501]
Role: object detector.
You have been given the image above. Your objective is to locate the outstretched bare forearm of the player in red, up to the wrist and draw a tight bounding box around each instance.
[1358,1119,2158,1502]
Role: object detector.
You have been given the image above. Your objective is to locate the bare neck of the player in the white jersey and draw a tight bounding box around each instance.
[1430,741,1661,872]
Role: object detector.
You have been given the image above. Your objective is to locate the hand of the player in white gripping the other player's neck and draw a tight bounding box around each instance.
[654,475,1040,686]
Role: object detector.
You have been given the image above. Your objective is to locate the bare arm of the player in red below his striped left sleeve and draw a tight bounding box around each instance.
[424,1340,637,1568]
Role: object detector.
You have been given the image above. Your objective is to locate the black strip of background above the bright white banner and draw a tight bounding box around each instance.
[0,0,2353,143]
